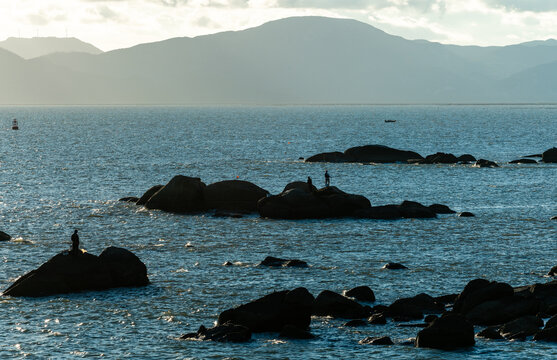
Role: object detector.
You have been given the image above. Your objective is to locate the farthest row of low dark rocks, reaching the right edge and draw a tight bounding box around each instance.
[305,145,557,167]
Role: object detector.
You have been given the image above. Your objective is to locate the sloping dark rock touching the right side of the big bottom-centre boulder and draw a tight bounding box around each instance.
[312,290,369,319]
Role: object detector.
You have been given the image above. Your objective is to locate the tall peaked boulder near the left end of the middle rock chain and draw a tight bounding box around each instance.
[145,175,205,213]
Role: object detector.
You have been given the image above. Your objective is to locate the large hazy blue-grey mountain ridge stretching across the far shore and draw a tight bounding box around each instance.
[0,17,557,104]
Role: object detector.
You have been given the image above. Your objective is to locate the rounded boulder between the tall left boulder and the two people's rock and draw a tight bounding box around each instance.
[203,180,269,212]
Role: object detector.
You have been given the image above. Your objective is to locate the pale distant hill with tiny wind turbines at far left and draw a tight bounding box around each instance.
[0,37,102,59]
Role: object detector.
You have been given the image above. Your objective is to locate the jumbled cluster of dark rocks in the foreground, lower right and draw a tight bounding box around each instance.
[181,279,557,350]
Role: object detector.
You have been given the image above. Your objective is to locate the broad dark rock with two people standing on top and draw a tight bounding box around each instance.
[257,186,371,219]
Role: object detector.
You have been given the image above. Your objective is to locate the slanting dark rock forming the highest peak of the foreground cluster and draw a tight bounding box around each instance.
[453,279,514,314]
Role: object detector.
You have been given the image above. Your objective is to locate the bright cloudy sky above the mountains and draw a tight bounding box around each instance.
[0,0,557,51]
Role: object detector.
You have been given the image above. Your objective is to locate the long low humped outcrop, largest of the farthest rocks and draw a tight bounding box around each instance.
[305,145,423,163]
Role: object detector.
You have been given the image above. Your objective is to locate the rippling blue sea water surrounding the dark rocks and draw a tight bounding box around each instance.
[0,105,557,359]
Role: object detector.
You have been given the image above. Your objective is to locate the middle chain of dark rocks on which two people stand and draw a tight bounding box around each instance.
[124,175,466,220]
